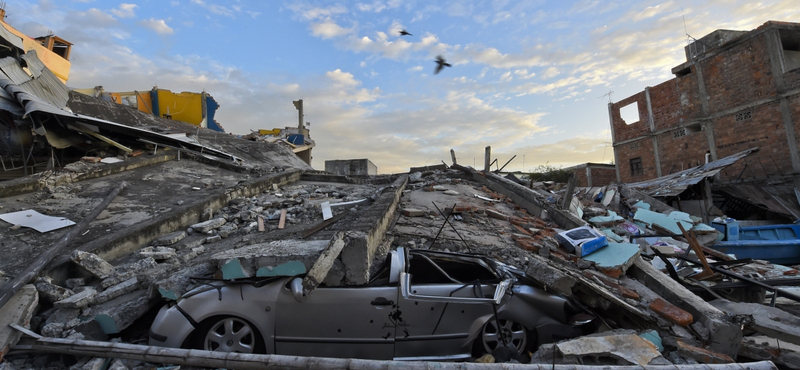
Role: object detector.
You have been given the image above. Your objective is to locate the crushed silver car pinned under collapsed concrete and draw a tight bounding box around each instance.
[150,248,594,360]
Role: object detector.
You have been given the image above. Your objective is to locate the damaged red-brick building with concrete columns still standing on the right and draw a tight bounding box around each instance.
[609,21,800,187]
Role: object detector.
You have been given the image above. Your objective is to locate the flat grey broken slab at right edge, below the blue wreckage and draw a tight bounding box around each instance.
[709,299,800,345]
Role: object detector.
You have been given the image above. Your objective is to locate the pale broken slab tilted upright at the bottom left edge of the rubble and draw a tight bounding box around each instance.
[0,284,39,360]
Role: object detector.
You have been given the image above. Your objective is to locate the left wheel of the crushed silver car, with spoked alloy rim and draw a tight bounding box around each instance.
[192,316,266,354]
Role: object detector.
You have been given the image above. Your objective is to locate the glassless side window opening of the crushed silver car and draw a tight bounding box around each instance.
[408,253,500,284]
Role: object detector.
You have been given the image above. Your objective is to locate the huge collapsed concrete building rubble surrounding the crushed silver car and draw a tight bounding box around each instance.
[0,12,800,369]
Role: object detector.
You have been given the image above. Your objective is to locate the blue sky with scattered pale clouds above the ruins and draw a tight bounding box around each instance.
[5,0,800,174]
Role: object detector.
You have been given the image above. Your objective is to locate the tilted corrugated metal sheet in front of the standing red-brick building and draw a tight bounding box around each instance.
[628,148,758,197]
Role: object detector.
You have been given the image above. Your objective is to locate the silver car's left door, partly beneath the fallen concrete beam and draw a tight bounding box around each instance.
[275,286,399,359]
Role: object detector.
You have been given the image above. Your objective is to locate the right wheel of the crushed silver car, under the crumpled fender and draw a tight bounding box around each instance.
[474,318,536,361]
